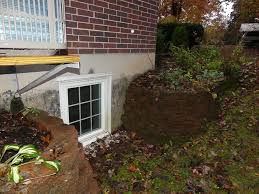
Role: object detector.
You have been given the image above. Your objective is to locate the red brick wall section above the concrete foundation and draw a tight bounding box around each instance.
[65,0,159,54]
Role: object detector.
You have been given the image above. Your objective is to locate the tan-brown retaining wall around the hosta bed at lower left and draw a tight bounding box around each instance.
[0,114,99,194]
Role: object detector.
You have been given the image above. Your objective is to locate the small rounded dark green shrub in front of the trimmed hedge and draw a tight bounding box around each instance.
[171,26,189,48]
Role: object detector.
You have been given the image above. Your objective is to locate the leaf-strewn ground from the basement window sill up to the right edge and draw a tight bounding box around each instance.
[86,62,259,193]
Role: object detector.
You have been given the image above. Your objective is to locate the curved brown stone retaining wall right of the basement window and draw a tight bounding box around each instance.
[123,85,218,143]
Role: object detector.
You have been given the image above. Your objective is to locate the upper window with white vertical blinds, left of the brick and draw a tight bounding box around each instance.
[0,0,66,49]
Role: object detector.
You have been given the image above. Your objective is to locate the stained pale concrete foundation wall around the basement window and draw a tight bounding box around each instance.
[0,53,155,129]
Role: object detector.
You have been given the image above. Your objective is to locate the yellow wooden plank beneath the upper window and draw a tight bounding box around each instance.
[0,56,80,66]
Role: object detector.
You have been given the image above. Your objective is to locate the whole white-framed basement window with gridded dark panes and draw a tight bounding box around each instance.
[58,74,111,145]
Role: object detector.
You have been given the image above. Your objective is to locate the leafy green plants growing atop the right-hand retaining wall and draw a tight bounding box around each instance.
[166,45,224,91]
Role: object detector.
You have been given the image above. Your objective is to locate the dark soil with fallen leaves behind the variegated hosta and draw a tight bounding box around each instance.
[0,110,50,161]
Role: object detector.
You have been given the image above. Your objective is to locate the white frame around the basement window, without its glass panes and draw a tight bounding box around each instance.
[57,73,112,146]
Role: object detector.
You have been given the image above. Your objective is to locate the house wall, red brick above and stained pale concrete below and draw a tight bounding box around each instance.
[0,0,159,129]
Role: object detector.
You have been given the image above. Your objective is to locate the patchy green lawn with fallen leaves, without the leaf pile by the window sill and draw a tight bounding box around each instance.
[101,87,259,193]
